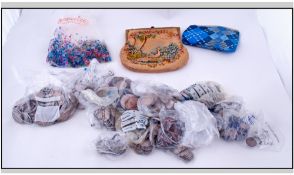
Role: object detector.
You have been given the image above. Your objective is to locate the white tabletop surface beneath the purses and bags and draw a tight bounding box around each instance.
[2,9,292,168]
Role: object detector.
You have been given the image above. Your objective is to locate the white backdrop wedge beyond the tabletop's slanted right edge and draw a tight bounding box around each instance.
[257,9,293,98]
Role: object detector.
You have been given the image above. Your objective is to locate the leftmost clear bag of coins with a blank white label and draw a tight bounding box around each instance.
[12,84,78,126]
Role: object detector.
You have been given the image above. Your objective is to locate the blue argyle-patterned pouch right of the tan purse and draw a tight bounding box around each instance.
[182,25,239,52]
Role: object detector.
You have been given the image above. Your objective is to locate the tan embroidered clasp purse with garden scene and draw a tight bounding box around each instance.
[120,27,188,72]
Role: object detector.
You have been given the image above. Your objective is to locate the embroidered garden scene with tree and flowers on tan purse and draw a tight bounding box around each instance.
[125,29,183,67]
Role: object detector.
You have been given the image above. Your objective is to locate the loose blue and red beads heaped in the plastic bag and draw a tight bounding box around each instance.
[47,28,111,67]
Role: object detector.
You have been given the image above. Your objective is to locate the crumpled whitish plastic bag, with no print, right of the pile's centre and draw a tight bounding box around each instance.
[175,100,219,148]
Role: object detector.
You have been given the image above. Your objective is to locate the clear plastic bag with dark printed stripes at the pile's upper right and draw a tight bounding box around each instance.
[178,81,226,108]
